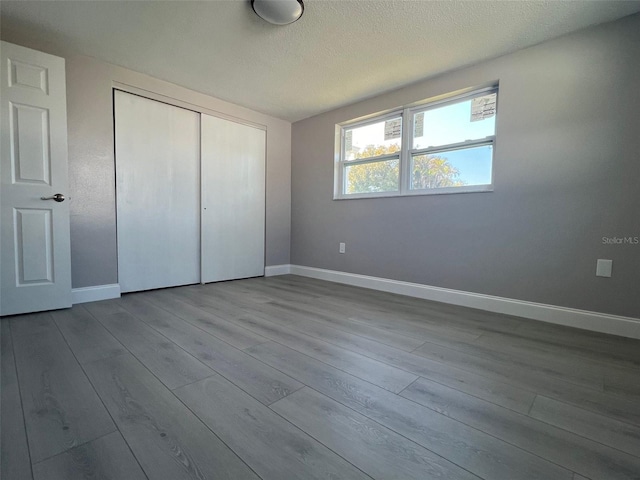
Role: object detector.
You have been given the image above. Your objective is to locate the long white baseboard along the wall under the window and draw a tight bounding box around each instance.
[287,265,640,339]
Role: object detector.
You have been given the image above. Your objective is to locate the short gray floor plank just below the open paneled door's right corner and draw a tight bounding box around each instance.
[51,305,127,363]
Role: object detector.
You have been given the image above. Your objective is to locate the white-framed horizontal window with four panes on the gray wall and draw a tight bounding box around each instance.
[334,87,498,198]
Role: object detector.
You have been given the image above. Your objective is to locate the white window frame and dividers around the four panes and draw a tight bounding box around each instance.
[333,84,499,200]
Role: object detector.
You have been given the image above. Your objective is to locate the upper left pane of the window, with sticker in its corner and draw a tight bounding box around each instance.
[344,117,402,160]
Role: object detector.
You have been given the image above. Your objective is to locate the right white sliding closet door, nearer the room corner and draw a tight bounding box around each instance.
[201,114,266,283]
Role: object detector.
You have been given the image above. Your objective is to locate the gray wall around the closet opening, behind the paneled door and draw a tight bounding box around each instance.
[2,26,291,288]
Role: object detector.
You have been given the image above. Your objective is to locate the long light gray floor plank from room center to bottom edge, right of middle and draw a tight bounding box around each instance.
[247,343,571,480]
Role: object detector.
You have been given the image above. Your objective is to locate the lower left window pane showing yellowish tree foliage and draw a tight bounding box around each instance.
[344,158,400,194]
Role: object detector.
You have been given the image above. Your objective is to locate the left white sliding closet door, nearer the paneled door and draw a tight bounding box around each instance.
[115,91,200,292]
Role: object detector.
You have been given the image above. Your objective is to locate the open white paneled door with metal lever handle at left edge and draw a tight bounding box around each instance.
[0,42,71,315]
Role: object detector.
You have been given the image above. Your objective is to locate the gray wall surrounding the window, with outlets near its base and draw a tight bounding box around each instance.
[291,15,640,317]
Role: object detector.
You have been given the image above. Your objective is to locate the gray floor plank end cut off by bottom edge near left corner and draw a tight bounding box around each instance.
[33,432,147,480]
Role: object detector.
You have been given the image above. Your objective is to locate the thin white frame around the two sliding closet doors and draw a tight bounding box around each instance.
[111,81,268,283]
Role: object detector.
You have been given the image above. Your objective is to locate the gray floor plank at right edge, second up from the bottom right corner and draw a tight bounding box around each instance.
[529,396,640,457]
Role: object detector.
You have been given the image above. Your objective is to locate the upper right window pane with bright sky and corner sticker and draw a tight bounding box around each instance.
[413,93,496,150]
